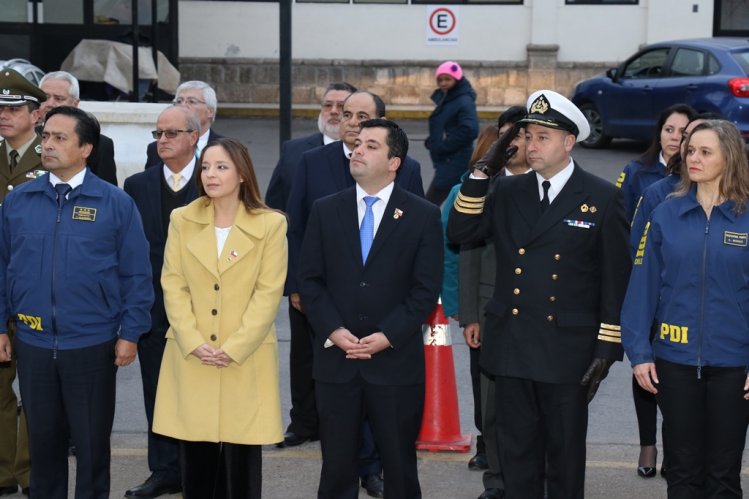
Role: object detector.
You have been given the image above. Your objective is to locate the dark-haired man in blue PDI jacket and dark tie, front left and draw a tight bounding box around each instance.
[0,106,153,499]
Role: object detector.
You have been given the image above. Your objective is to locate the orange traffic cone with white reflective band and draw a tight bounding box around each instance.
[416,303,471,452]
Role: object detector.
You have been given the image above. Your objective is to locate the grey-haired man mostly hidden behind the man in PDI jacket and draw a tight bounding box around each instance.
[37,71,117,185]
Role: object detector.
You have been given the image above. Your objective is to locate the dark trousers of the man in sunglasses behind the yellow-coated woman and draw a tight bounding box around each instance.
[138,331,180,483]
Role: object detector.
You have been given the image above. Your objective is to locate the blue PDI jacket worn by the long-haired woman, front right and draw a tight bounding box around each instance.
[621,186,749,375]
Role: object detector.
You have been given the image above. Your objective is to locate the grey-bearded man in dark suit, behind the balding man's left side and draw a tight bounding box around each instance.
[265,81,356,211]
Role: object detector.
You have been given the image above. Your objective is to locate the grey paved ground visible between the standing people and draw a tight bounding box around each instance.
[14,119,749,499]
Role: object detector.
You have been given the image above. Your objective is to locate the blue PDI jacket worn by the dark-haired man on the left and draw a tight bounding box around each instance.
[0,171,153,350]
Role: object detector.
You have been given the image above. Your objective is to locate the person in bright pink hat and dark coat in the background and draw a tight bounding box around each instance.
[425,61,479,206]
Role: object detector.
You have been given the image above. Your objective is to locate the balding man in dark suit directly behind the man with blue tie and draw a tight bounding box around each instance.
[284,92,424,497]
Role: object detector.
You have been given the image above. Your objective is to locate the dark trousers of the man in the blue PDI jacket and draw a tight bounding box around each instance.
[15,339,117,499]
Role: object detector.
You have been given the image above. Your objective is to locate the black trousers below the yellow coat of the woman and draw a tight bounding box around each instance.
[179,440,263,499]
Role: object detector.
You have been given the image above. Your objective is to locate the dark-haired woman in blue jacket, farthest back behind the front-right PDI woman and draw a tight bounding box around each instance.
[616,104,697,222]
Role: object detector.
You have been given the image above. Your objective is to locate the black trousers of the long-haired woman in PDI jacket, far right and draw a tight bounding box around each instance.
[656,360,749,499]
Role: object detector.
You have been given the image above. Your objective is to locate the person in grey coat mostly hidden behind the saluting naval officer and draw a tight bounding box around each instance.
[458,106,530,499]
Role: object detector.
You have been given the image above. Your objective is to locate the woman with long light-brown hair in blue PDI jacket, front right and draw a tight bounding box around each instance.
[621,120,749,498]
